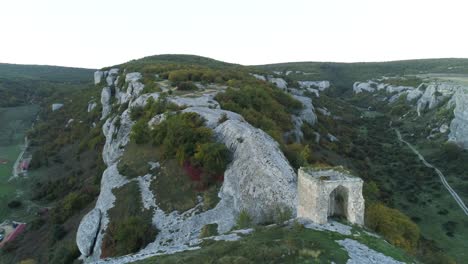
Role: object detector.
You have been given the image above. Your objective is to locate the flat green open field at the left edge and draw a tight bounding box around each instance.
[0,105,38,221]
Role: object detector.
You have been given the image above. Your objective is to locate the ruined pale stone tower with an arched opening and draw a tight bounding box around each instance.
[297,167,364,225]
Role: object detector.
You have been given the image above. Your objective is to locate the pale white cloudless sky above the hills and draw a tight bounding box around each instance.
[0,0,468,68]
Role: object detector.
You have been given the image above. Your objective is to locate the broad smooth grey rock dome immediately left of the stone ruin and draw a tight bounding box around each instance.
[215,120,297,222]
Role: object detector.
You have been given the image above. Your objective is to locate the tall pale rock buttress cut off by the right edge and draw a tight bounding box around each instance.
[449,87,468,149]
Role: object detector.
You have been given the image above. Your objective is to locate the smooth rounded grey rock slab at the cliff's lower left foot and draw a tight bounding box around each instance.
[76,208,101,257]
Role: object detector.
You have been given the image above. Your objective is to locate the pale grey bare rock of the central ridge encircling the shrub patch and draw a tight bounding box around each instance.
[77,69,300,262]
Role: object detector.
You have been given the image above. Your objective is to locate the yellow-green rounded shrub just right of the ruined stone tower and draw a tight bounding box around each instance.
[366,203,420,252]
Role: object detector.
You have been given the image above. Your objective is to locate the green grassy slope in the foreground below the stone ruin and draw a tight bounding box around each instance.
[136,224,412,264]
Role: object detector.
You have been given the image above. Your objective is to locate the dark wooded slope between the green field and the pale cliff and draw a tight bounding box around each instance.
[0,86,104,263]
